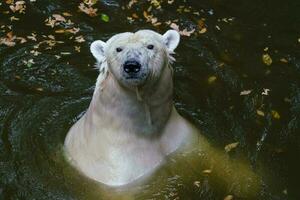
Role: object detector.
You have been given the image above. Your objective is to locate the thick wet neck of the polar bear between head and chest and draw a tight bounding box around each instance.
[87,66,173,137]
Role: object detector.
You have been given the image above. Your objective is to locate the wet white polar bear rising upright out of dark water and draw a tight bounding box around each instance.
[65,30,197,186]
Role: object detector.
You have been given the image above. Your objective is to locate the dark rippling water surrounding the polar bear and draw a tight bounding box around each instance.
[0,0,300,199]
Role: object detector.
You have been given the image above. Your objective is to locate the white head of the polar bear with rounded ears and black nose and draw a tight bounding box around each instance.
[90,30,180,88]
